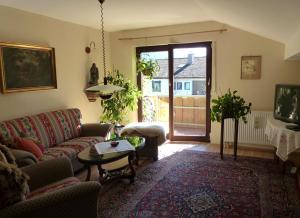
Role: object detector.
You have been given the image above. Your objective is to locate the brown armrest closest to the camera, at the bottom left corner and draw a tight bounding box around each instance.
[0,181,101,218]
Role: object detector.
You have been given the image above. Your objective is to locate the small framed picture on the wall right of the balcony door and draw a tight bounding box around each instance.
[241,56,261,79]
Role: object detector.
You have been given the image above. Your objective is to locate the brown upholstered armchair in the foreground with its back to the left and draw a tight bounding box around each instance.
[0,157,101,218]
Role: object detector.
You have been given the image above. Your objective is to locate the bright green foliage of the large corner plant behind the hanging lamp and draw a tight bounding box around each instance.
[100,70,141,124]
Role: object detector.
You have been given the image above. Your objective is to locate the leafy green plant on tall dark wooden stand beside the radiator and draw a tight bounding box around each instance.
[211,89,252,159]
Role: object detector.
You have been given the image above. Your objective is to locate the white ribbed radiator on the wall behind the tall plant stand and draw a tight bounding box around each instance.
[224,111,273,145]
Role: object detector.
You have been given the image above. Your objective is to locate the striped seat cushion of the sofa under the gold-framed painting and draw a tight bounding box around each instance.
[41,136,104,160]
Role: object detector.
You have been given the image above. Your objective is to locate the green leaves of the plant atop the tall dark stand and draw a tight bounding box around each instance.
[211,89,252,123]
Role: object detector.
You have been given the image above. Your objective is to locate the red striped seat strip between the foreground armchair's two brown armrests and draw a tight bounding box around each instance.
[27,177,80,199]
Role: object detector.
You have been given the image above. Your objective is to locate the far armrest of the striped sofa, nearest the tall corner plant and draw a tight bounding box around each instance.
[81,123,113,138]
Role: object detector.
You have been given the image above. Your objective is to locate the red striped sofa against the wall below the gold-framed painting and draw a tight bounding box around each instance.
[0,108,112,171]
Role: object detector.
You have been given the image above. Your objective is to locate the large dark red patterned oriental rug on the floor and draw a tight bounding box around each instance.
[99,150,300,218]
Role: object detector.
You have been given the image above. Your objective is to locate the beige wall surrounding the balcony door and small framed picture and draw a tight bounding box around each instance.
[110,22,300,143]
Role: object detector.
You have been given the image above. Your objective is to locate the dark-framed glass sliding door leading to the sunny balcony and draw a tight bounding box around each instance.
[136,42,211,141]
